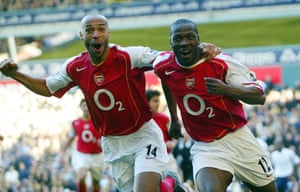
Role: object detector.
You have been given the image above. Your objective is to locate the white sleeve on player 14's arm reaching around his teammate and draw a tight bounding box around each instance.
[125,46,160,68]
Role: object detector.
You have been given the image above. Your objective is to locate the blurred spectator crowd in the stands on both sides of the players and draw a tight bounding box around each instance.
[0,78,300,192]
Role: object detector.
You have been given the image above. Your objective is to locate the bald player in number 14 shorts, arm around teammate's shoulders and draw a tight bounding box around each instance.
[0,15,220,192]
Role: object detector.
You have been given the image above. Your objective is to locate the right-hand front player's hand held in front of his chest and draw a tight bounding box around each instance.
[204,77,227,95]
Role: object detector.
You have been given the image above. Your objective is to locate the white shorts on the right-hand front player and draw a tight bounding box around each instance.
[191,126,274,187]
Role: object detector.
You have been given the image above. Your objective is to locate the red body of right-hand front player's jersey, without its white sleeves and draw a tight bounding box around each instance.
[155,52,244,141]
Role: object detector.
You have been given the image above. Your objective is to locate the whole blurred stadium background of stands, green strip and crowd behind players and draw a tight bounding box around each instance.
[0,0,300,192]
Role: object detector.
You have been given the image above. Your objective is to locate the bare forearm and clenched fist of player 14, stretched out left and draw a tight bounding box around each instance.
[0,59,52,97]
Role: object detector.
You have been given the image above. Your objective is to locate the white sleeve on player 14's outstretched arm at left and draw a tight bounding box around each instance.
[46,58,73,94]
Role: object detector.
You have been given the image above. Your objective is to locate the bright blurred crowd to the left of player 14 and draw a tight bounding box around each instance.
[0,84,119,192]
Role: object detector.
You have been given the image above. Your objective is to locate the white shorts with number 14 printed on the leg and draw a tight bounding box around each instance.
[102,119,169,192]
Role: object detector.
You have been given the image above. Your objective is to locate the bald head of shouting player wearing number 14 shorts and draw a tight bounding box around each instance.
[80,15,110,65]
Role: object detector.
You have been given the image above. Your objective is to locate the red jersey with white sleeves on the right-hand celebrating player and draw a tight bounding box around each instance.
[154,52,260,142]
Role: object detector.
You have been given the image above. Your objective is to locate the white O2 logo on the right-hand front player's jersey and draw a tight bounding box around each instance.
[183,94,215,118]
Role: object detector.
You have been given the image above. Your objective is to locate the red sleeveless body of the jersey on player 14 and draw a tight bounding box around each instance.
[71,49,151,135]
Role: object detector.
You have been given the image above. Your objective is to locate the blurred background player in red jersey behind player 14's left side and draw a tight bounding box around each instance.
[61,99,104,192]
